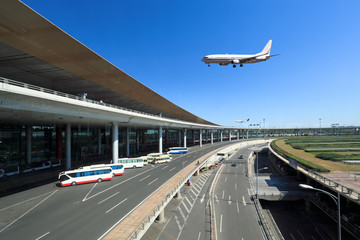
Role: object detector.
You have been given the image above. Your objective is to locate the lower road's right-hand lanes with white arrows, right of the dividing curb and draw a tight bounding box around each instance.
[214,149,264,240]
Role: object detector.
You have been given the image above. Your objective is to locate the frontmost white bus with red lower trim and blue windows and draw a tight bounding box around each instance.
[59,167,113,187]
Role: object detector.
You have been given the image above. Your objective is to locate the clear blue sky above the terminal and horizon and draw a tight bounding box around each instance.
[24,0,360,127]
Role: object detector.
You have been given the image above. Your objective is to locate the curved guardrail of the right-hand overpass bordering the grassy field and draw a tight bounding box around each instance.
[269,145,360,201]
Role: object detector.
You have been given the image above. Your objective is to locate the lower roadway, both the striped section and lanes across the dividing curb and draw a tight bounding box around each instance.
[150,143,263,240]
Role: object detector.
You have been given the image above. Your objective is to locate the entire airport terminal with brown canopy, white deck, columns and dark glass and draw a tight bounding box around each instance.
[0,0,236,176]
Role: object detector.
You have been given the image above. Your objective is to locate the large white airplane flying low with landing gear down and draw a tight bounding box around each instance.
[201,40,279,67]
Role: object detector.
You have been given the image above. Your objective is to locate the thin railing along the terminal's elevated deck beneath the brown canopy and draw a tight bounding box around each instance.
[0,77,200,124]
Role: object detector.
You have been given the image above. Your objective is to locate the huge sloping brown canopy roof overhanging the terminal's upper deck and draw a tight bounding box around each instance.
[0,0,214,125]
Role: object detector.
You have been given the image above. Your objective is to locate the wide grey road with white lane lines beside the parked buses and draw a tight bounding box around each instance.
[0,141,242,239]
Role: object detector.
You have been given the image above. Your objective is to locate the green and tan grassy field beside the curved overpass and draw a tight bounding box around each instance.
[271,135,360,172]
